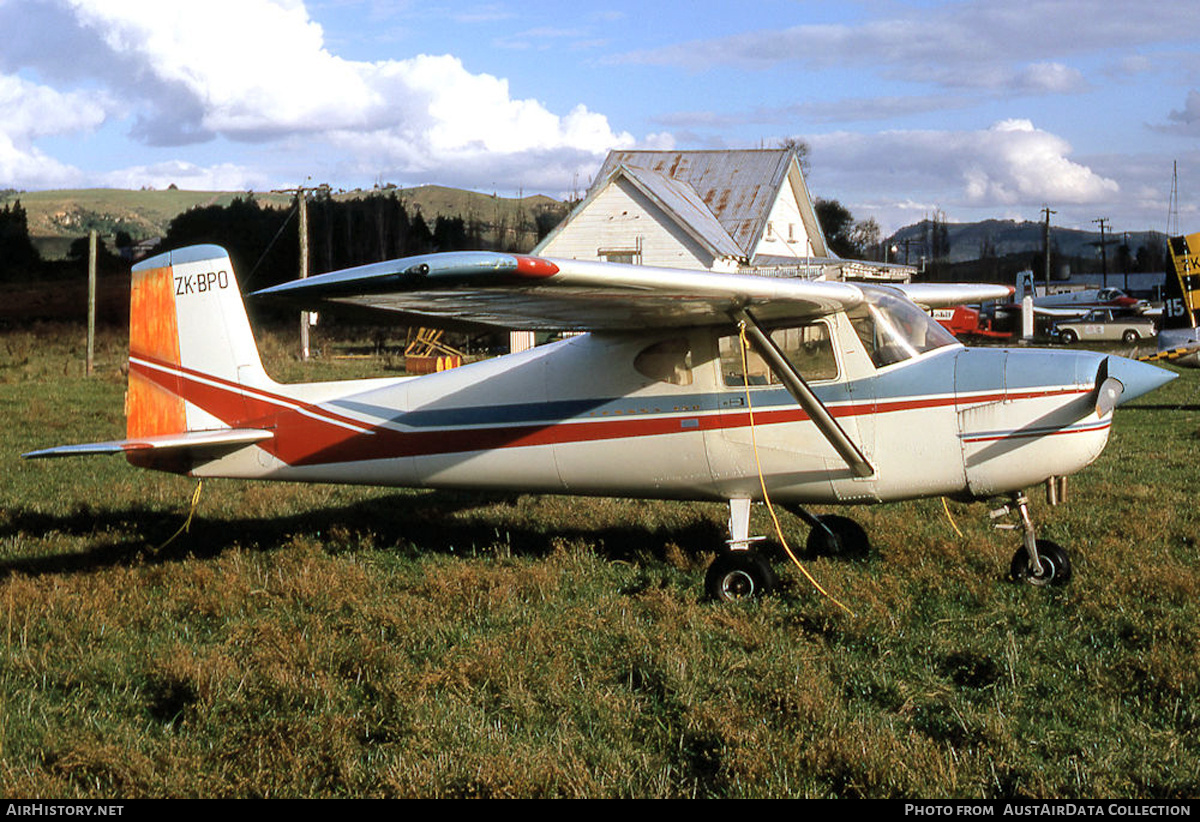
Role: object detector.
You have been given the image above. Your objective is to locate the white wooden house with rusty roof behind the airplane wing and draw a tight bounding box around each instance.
[512,149,913,350]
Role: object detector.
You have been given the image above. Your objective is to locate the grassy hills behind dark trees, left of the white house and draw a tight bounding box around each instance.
[0,186,569,259]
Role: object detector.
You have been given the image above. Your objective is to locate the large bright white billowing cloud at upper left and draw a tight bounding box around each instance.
[0,0,635,185]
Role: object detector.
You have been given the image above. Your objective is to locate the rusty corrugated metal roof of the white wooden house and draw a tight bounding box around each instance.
[596,149,792,257]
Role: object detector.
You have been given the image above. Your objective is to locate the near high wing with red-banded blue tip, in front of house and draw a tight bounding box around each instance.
[253,252,864,331]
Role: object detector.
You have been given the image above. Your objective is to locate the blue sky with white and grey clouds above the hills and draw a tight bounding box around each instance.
[0,0,1200,235]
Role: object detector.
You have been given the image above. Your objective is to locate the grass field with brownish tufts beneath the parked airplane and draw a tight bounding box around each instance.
[0,326,1200,798]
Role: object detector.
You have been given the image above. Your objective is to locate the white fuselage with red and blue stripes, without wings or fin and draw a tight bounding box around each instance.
[142,314,1123,503]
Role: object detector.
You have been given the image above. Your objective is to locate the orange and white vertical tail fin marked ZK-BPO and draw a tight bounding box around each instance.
[126,246,272,439]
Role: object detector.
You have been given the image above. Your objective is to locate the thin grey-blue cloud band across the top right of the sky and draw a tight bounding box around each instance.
[610,0,1194,94]
